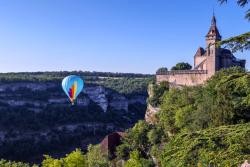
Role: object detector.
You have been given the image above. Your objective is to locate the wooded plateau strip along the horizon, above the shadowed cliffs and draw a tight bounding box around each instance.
[0,71,154,94]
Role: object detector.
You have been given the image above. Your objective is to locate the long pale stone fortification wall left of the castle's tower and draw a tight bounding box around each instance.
[156,70,209,86]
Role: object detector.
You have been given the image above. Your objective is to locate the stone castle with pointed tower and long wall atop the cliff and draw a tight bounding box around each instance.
[156,15,246,86]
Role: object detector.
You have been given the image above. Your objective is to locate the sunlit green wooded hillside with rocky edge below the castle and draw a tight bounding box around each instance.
[115,67,250,167]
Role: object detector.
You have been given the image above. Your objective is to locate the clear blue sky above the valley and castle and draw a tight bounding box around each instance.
[0,0,250,73]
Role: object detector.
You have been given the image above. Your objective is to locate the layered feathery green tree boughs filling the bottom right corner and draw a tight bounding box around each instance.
[160,123,250,167]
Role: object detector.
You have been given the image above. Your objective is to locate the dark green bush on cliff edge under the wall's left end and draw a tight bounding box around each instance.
[148,82,169,107]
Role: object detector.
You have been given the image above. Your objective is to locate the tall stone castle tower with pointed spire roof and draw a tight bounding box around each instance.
[206,14,221,77]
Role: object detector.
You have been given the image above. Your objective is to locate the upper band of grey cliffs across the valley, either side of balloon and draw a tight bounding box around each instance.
[0,82,146,112]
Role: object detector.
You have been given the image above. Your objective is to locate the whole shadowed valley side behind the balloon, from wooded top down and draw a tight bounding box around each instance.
[0,71,153,162]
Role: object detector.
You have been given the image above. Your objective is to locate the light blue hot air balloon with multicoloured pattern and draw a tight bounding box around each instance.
[62,75,84,105]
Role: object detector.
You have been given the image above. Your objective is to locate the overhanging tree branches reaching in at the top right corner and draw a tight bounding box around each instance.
[216,0,250,52]
